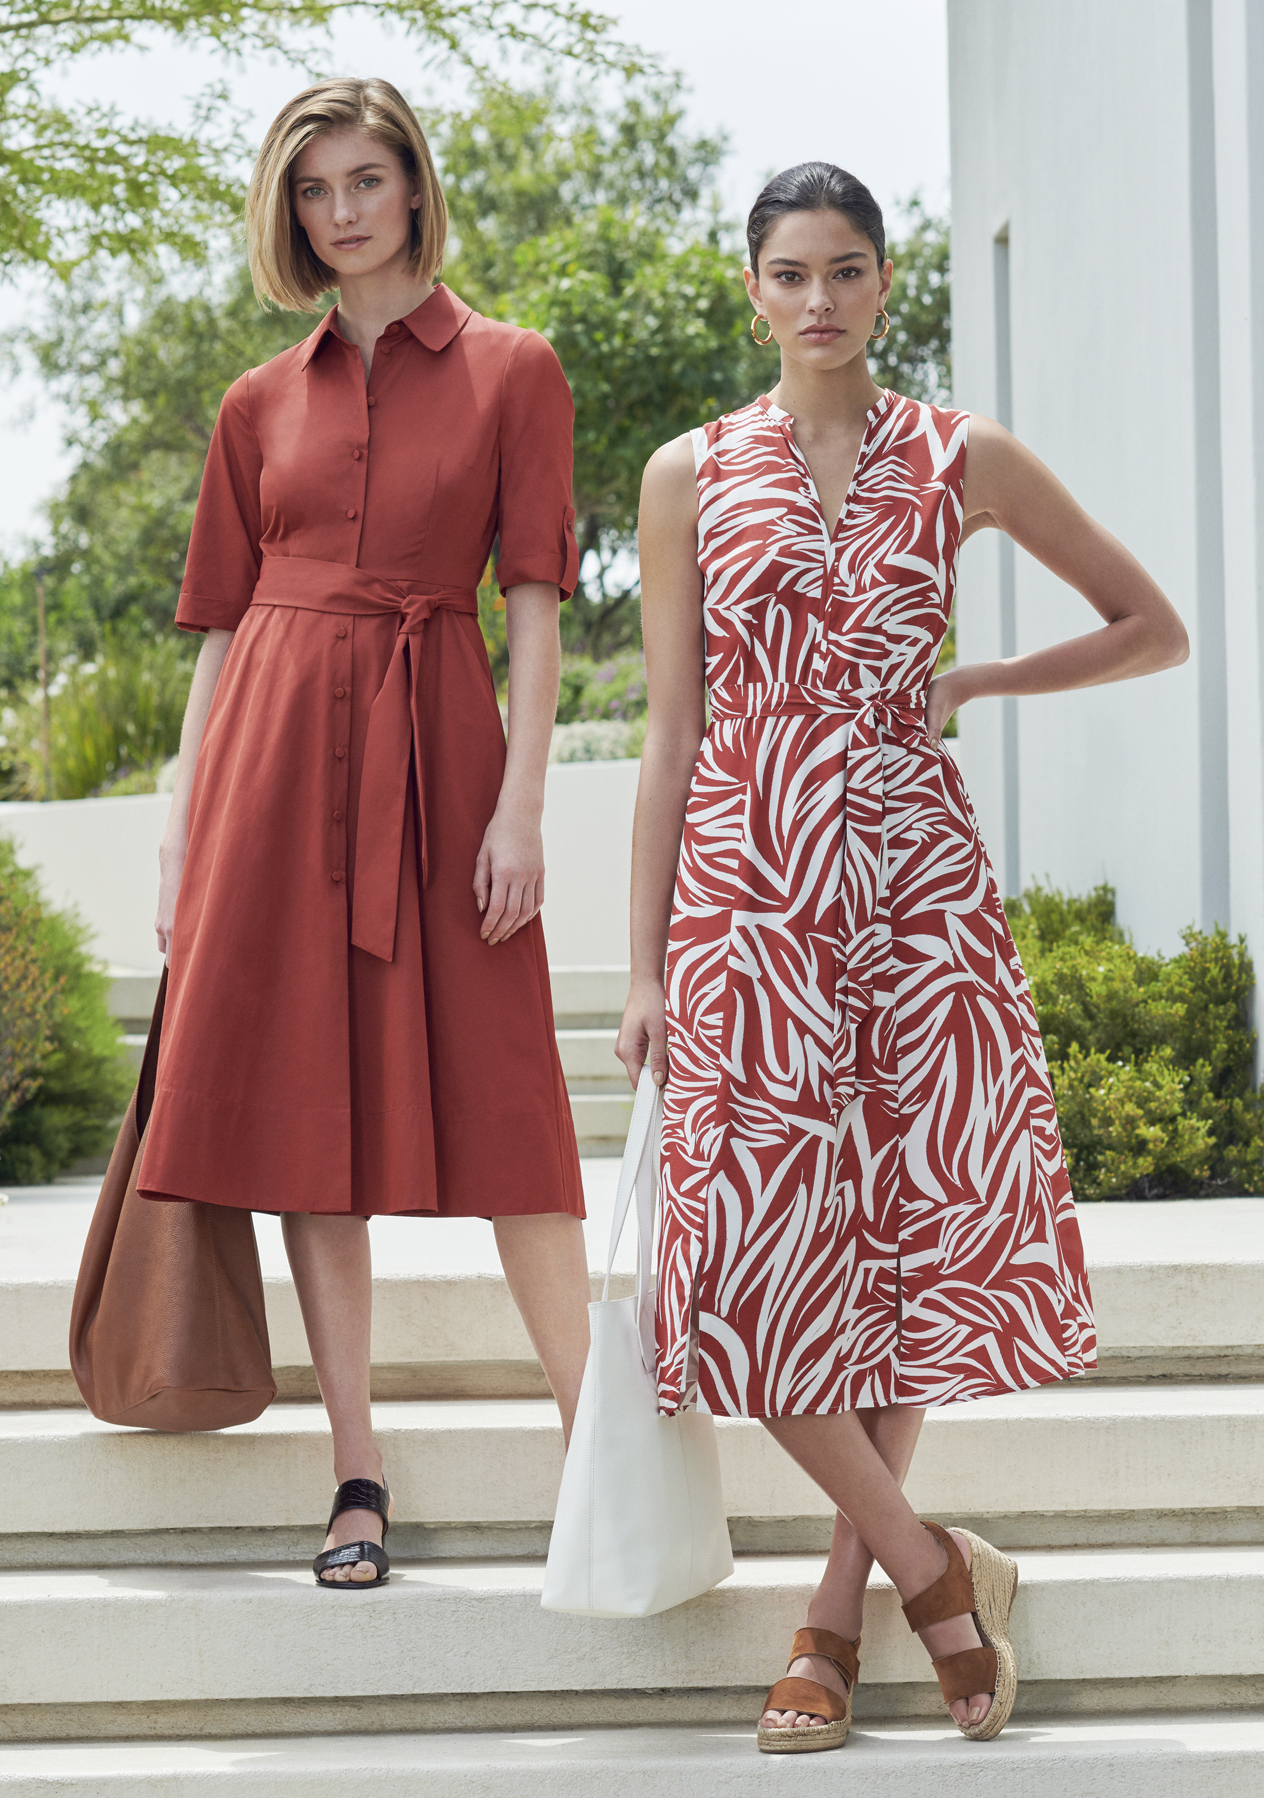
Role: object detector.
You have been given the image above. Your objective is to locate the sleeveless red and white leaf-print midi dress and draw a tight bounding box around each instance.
[658,392,1095,1417]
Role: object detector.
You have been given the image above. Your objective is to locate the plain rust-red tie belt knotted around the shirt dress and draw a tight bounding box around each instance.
[250,556,478,962]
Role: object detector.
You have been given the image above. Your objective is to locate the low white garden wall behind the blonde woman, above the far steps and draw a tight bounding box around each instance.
[0,762,640,973]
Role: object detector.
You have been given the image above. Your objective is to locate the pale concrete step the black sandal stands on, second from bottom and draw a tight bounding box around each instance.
[0,1548,1264,1740]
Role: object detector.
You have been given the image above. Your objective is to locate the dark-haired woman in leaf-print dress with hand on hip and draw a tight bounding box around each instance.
[619,164,1187,1751]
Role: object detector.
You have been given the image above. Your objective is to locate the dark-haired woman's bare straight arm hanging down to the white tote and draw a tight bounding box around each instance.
[615,437,707,1086]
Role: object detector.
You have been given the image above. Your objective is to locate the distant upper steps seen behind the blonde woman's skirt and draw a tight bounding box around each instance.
[110,967,631,1156]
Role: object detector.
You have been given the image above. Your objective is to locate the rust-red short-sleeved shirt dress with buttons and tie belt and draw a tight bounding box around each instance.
[140,286,583,1217]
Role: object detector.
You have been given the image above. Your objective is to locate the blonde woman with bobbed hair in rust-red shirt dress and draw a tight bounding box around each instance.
[140,79,588,1591]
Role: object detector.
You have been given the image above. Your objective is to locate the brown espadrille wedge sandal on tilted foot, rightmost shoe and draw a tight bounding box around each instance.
[904,1518,1018,1742]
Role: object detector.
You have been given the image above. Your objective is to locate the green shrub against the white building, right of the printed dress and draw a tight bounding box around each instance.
[1005,886,1264,1199]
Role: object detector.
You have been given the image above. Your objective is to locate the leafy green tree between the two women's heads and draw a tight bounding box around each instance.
[433,79,757,658]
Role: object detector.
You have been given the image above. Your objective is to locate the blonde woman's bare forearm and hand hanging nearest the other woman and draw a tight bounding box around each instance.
[475,581,561,942]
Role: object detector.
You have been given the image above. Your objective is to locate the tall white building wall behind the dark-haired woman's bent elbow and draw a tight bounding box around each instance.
[948,0,1264,966]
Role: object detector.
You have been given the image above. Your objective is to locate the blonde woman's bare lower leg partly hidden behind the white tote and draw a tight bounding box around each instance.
[494,1212,592,1446]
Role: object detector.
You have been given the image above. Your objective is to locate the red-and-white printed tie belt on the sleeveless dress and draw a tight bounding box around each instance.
[710,685,930,1122]
